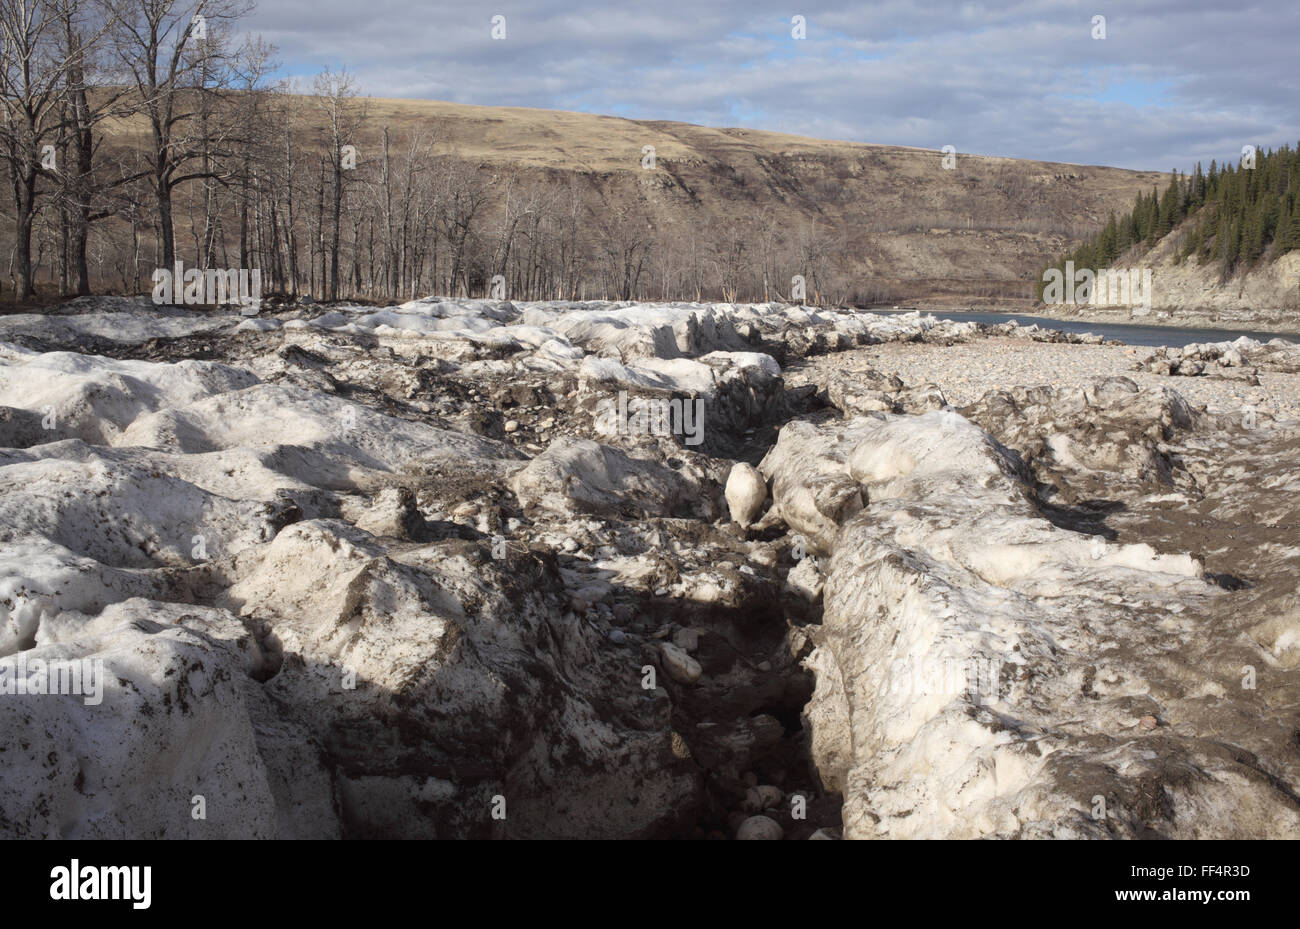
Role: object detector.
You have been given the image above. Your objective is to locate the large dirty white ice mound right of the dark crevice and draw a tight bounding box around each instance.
[763,412,1300,838]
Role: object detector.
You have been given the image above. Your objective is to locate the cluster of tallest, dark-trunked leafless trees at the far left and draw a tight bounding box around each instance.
[0,0,267,299]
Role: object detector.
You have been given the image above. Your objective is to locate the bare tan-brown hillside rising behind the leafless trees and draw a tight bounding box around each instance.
[367,99,1167,301]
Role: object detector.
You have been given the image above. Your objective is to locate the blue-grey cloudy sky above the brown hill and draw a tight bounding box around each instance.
[243,0,1300,170]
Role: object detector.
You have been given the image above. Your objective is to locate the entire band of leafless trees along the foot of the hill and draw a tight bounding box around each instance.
[0,0,887,303]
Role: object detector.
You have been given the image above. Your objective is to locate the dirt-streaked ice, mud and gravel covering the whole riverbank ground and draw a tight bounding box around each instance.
[0,298,1300,839]
